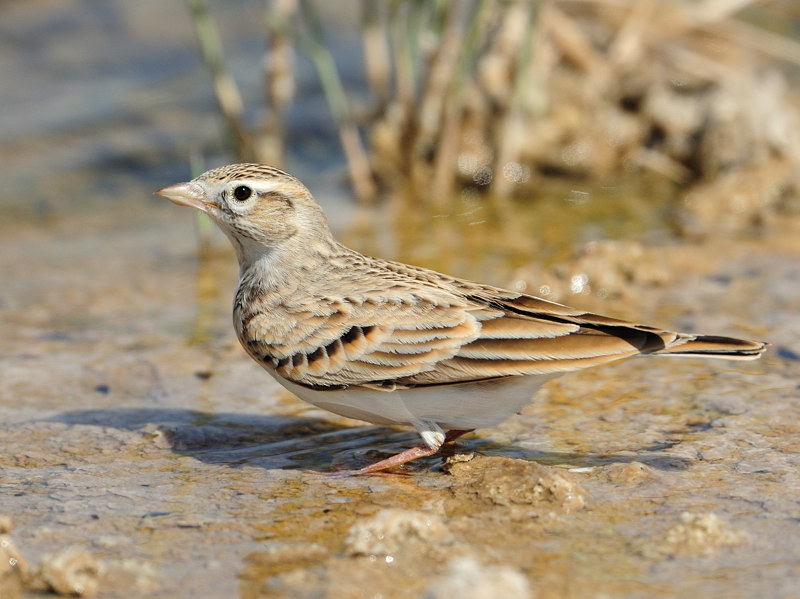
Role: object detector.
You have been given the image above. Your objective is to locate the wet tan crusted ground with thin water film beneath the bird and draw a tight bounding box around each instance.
[0,221,800,597]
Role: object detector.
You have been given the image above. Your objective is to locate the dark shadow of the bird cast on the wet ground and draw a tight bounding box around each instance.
[47,408,691,471]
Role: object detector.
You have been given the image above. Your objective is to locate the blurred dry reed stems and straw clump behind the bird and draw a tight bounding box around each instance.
[187,0,800,236]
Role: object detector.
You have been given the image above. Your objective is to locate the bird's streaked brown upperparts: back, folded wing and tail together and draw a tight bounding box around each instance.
[234,231,764,389]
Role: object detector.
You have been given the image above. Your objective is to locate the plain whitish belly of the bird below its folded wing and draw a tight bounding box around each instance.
[275,375,554,429]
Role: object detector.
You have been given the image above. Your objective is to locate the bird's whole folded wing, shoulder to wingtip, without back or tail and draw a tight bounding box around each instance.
[245,274,675,388]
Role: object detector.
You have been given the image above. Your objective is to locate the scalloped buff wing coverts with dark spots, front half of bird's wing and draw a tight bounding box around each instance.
[243,289,494,387]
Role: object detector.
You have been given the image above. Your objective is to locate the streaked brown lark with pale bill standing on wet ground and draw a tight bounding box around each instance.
[155,163,768,475]
